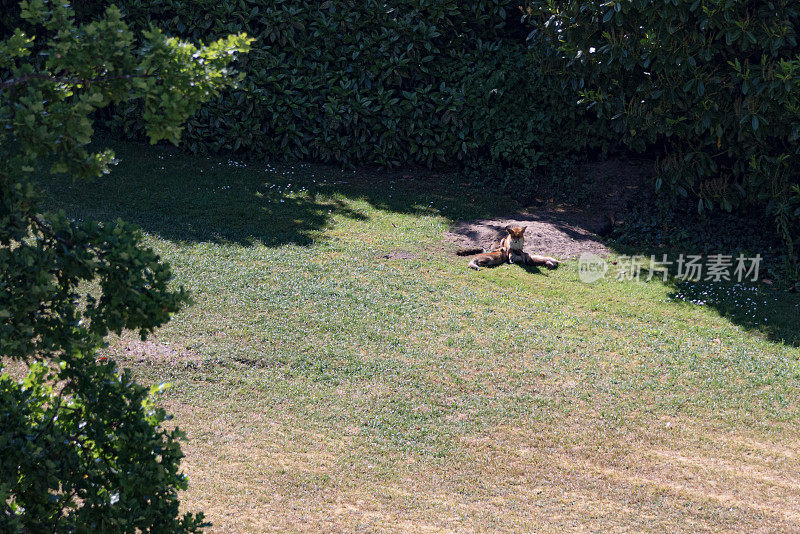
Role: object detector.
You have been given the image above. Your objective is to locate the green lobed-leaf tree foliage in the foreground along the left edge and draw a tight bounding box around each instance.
[0,0,251,533]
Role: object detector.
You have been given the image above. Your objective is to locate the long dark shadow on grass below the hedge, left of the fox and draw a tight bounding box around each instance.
[34,143,516,246]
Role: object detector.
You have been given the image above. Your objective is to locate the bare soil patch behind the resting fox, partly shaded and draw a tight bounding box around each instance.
[445,161,652,259]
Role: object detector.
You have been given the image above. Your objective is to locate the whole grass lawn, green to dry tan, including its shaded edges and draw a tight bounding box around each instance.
[37,144,800,532]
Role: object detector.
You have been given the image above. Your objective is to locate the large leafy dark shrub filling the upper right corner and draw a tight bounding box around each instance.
[528,0,800,258]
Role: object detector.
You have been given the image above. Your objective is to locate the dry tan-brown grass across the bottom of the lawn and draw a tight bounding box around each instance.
[169,396,800,532]
